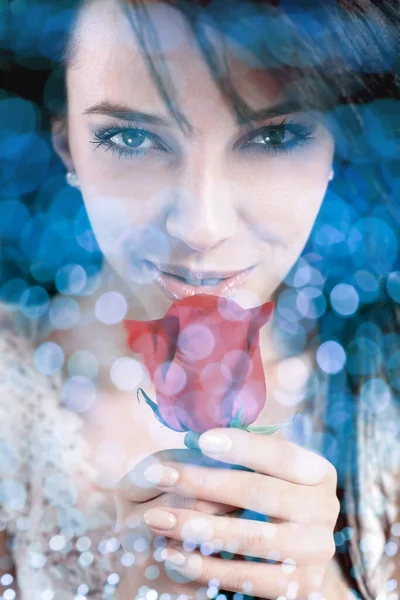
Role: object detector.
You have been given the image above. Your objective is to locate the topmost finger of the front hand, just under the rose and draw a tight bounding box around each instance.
[199,428,336,487]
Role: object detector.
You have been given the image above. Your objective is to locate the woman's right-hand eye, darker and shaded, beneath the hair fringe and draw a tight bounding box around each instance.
[242,121,315,154]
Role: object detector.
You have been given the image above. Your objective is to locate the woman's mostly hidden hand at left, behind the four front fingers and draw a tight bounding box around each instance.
[114,450,236,600]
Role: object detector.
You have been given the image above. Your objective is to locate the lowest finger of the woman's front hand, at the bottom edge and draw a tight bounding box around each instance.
[162,548,326,600]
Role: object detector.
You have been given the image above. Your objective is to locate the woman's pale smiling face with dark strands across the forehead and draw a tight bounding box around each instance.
[58,0,334,318]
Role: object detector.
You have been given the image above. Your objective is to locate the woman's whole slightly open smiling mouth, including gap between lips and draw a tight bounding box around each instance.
[147,262,254,300]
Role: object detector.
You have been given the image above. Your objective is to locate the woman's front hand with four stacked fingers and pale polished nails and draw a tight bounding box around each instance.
[139,428,340,600]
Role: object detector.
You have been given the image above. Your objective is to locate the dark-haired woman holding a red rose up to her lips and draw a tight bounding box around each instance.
[2,0,399,600]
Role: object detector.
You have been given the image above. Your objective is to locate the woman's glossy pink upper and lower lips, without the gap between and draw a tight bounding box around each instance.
[148,263,254,300]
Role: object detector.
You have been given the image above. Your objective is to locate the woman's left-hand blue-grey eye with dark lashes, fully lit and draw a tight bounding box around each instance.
[91,125,168,158]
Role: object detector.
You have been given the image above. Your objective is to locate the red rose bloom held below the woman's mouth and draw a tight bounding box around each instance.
[124,294,274,433]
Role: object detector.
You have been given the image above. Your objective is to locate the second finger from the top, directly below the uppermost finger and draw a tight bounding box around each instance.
[147,463,340,525]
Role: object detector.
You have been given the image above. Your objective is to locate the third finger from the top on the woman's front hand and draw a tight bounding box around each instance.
[144,509,336,565]
